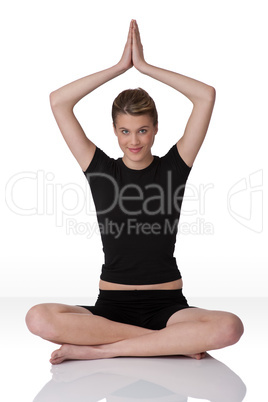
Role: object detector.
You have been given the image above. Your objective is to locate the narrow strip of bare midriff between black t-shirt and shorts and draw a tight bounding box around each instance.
[99,279,182,290]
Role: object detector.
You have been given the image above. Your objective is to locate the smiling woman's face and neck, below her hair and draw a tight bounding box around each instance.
[114,114,158,169]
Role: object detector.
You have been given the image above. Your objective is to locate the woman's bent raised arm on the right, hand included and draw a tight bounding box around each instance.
[132,21,216,166]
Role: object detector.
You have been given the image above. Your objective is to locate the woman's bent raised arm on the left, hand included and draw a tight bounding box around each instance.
[50,21,133,171]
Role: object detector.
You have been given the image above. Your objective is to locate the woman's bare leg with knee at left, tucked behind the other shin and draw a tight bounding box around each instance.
[26,303,153,345]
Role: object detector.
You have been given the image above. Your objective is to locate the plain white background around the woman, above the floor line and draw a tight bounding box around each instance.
[0,0,268,297]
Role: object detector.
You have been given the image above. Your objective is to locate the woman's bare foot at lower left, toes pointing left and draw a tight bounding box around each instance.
[50,345,111,364]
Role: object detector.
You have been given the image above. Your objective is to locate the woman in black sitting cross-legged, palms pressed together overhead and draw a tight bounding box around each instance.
[26,20,243,364]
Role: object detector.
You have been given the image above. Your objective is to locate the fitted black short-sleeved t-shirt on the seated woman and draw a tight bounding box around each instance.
[84,145,191,285]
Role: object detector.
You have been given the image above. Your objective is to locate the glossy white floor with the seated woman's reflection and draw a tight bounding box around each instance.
[0,298,268,402]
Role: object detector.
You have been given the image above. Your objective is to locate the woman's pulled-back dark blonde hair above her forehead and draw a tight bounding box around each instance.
[112,88,158,126]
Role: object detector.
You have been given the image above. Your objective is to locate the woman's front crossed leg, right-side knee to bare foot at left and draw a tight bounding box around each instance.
[48,309,243,364]
